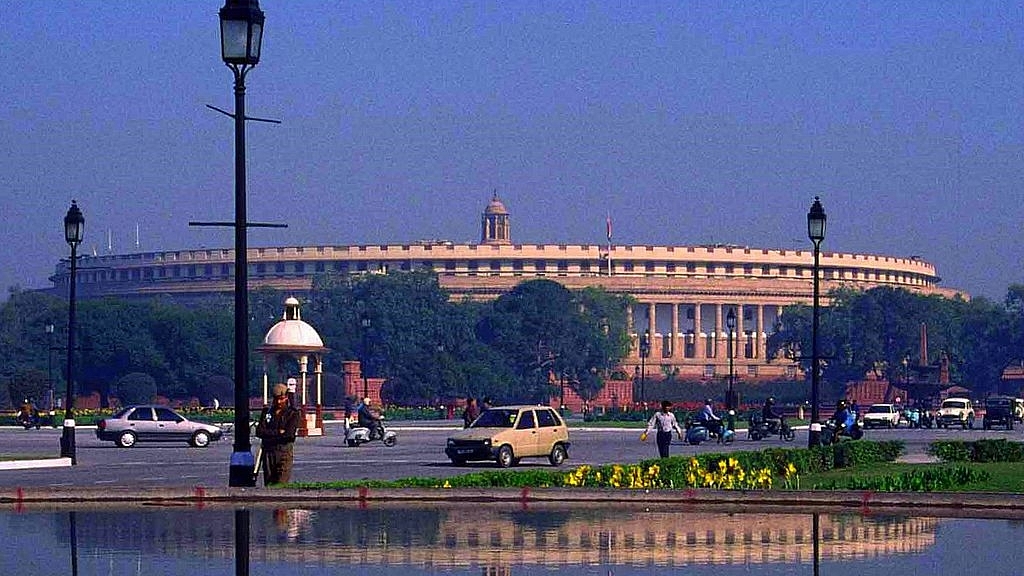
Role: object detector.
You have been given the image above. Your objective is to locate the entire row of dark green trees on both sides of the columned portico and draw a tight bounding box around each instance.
[0,272,1024,406]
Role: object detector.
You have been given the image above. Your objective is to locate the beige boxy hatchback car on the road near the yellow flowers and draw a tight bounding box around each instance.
[444,406,569,468]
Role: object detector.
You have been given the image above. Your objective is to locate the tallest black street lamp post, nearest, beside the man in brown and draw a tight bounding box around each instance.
[220,0,263,486]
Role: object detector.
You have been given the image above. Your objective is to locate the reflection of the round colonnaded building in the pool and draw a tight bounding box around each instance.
[64,505,939,574]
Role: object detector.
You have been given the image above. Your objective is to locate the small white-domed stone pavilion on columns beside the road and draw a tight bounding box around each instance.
[256,297,328,436]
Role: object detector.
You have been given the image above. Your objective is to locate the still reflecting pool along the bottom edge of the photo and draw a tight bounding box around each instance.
[0,504,1024,576]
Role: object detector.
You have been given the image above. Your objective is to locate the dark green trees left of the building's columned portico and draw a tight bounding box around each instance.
[0,273,629,406]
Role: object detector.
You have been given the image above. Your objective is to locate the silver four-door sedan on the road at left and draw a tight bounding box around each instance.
[96,405,224,448]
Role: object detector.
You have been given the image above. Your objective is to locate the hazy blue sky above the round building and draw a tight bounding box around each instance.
[0,0,1024,300]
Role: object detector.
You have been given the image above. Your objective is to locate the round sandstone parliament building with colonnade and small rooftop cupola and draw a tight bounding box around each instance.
[50,195,962,380]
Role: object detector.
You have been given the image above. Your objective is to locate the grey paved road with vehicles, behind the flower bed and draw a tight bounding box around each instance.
[0,422,1011,488]
